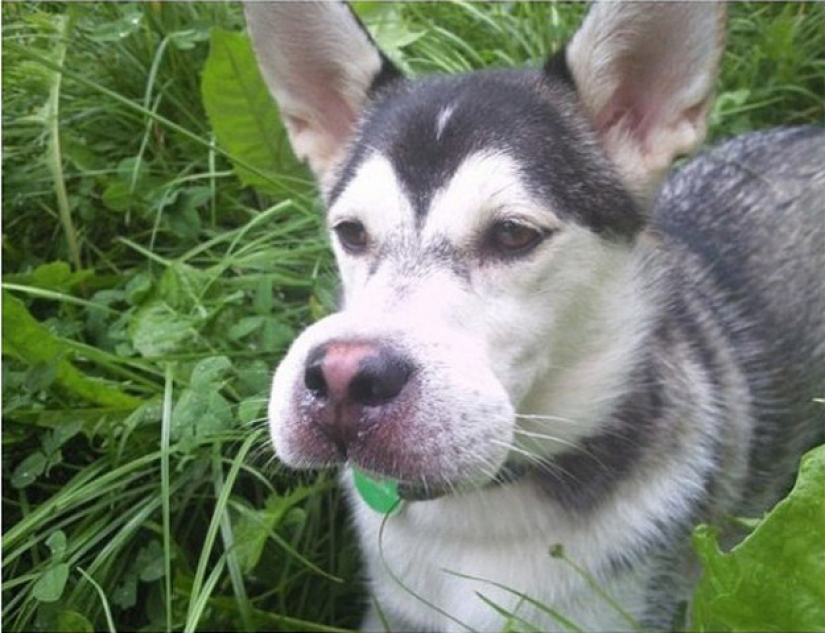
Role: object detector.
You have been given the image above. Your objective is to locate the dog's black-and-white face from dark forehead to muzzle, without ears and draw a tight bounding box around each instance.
[270,73,641,487]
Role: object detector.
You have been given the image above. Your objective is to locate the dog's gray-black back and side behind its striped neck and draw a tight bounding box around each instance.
[654,128,825,514]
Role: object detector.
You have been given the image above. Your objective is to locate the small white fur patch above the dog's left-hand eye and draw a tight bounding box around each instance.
[327,154,415,237]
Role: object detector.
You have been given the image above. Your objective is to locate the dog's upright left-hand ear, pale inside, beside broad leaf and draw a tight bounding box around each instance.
[244,0,401,181]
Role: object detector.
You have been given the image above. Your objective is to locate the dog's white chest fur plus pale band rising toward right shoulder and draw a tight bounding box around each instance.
[344,402,712,631]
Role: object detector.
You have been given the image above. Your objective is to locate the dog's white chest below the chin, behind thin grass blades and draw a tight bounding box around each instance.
[346,476,646,631]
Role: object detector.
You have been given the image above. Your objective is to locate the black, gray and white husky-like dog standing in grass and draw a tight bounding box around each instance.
[245,2,825,631]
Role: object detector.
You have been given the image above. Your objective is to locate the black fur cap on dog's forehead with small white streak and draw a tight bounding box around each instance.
[327,70,642,236]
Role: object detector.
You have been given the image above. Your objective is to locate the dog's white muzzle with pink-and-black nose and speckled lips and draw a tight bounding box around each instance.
[269,313,515,497]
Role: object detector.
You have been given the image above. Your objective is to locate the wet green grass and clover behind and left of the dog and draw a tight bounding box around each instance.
[2,2,825,631]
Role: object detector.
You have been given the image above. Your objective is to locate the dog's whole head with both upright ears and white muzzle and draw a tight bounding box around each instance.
[246,2,724,496]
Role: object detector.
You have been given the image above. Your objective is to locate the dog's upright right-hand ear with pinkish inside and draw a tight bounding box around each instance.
[566,2,725,203]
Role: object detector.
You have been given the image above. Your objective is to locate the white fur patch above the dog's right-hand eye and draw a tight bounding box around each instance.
[423,151,558,245]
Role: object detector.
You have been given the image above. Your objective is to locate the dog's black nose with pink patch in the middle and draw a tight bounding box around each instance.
[304,341,412,457]
